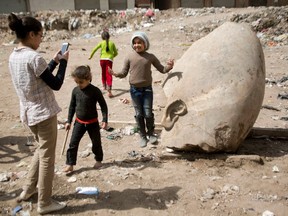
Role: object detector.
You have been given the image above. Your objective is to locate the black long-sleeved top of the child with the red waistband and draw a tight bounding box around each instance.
[67,84,108,124]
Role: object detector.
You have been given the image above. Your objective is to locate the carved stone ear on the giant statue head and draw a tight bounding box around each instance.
[161,99,187,131]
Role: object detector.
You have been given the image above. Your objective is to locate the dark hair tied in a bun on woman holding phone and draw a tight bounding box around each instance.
[8,13,43,40]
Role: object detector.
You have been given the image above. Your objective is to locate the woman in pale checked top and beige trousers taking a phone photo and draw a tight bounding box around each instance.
[8,13,69,214]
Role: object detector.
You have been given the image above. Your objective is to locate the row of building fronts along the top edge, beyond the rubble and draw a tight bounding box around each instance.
[0,0,288,13]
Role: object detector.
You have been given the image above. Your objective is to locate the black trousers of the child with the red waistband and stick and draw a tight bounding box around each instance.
[66,121,103,165]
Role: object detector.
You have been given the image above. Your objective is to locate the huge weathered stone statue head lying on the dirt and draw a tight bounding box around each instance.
[161,22,265,152]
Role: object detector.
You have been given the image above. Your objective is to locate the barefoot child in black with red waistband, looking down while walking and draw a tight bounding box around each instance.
[64,66,108,172]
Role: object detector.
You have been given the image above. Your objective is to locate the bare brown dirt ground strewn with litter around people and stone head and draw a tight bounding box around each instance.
[0,8,288,216]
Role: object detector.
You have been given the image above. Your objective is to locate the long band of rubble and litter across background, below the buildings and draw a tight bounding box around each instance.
[0,6,288,46]
